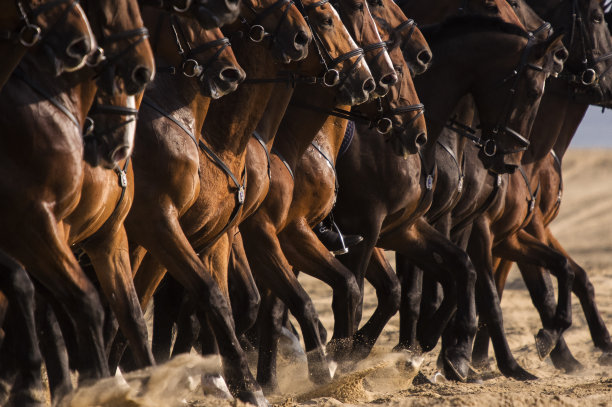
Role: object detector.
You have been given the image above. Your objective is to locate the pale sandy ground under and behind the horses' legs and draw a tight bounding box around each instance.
[66,150,612,406]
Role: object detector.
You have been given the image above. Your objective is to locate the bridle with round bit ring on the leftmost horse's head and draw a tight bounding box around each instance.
[0,0,78,48]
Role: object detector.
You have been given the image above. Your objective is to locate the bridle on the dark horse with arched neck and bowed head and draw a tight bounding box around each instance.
[479,22,551,157]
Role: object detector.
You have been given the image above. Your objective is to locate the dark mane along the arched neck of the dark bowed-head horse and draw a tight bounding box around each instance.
[421,14,529,42]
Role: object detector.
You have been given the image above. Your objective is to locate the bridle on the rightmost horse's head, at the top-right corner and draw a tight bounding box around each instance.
[559,0,612,87]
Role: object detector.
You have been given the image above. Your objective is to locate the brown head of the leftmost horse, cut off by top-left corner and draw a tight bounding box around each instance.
[0,0,95,90]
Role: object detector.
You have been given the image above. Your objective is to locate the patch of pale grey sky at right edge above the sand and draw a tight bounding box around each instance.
[570,106,612,148]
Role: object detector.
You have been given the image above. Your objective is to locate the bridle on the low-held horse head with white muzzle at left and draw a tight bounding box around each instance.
[83,102,138,167]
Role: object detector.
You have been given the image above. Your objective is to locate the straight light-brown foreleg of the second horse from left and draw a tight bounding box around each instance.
[84,226,155,368]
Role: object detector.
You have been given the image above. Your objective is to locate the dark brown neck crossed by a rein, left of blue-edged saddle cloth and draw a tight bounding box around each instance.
[274,85,337,169]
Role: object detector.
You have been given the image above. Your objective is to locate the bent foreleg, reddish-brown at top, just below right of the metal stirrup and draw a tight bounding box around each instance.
[351,248,401,360]
